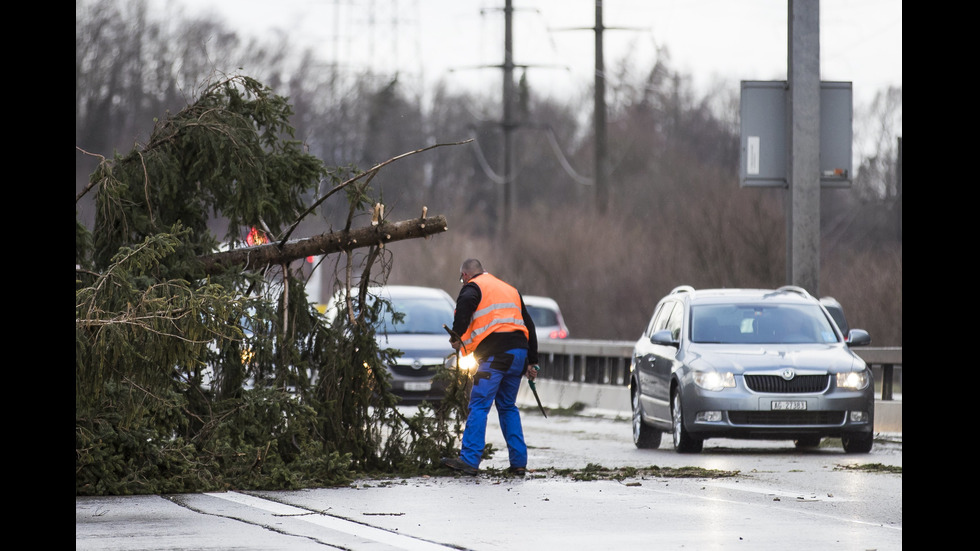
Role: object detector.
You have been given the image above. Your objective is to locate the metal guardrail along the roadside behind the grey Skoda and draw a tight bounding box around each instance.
[538,339,902,400]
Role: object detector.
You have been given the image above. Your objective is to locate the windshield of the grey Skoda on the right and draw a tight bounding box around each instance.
[691,304,838,344]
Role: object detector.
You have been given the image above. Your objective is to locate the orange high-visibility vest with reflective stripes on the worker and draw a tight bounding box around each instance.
[462,272,528,351]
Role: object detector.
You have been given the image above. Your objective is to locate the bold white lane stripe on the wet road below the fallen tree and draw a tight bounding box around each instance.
[204,492,455,551]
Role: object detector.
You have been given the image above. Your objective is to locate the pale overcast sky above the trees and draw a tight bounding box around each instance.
[153,0,902,108]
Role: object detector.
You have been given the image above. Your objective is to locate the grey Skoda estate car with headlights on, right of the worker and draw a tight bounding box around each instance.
[629,285,875,453]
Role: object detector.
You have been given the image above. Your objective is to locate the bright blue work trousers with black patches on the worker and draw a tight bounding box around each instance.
[459,348,527,468]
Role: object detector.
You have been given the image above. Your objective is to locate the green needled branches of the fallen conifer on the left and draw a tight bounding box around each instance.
[75,76,466,495]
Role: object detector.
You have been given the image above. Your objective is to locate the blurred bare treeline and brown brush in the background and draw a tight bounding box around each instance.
[75,0,902,346]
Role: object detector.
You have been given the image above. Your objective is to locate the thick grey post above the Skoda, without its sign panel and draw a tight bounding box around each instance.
[787,0,820,296]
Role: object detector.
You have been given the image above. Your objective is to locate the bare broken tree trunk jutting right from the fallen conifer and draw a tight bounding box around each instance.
[200,215,448,275]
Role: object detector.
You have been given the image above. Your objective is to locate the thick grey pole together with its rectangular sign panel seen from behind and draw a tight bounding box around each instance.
[740,0,853,296]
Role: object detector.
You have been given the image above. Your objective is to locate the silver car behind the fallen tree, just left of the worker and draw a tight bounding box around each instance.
[325,285,456,404]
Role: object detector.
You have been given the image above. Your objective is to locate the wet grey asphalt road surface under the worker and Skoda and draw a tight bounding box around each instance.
[75,412,902,551]
